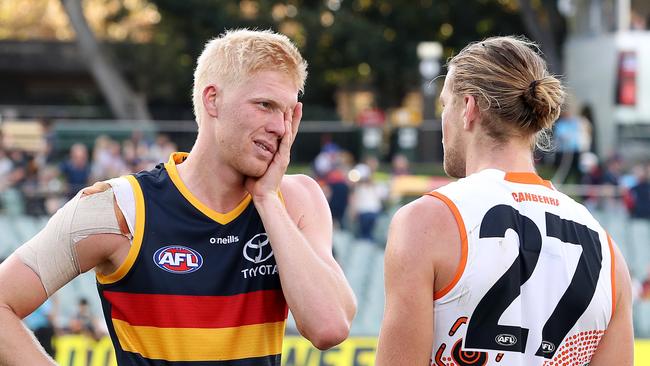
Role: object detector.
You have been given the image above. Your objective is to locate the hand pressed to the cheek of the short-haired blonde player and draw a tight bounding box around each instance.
[245,102,302,200]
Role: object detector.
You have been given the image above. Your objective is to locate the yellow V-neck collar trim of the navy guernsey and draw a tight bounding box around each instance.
[165,153,251,225]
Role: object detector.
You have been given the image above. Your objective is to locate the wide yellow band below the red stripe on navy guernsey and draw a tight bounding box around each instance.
[113,319,284,361]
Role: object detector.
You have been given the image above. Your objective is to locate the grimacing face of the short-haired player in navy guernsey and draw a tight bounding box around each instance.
[215,71,298,177]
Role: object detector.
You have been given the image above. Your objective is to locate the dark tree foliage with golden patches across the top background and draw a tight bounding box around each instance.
[0,0,566,119]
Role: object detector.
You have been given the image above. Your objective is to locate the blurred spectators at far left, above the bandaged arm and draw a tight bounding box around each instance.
[0,130,177,216]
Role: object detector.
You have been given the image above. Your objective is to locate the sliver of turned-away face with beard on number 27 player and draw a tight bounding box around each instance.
[440,67,466,178]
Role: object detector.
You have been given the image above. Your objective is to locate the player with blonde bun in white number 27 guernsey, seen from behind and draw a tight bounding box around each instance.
[377,37,633,366]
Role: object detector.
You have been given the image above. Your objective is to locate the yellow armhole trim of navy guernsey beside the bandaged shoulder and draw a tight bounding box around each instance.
[97,175,145,285]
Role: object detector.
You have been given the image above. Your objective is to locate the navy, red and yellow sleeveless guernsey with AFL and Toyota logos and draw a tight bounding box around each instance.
[97,154,288,366]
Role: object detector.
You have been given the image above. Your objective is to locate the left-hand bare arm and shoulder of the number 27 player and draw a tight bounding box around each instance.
[377,197,460,366]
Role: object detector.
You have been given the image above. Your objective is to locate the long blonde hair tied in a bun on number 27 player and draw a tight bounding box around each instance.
[448,36,565,147]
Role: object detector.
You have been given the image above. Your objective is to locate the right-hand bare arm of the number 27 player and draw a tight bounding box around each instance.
[590,240,634,366]
